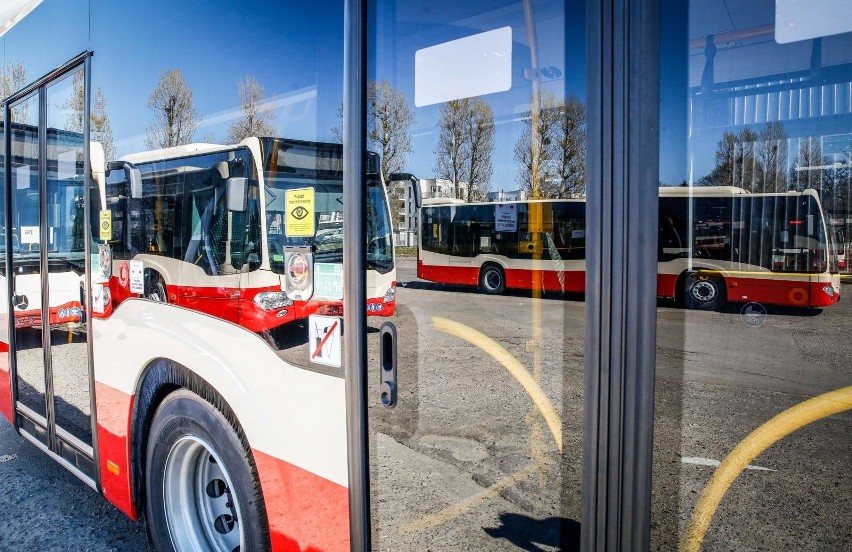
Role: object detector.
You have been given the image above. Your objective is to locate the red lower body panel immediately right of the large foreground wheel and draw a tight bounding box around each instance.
[252,449,349,552]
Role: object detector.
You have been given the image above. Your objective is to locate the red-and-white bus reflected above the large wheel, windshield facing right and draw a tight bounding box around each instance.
[92,138,396,332]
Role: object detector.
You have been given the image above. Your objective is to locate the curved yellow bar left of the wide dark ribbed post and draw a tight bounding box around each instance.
[432,316,562,452]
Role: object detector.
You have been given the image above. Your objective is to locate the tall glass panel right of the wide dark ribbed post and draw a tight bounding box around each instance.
[652,0,852,550]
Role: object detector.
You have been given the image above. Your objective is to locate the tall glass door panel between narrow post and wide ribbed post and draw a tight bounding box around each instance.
[367,0,586,550]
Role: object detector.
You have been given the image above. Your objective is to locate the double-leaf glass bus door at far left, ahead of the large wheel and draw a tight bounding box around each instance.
[5,60,95,486]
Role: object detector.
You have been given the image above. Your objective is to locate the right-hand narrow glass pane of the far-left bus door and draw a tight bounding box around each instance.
[44,68,92,444]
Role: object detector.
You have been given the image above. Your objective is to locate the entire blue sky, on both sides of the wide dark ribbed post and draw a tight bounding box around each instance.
[5,0,850,191]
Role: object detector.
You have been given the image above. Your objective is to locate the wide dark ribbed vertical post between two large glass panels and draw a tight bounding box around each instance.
[581,0,659,551]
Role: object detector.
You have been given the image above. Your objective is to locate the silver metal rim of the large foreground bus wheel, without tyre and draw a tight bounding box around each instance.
[163,436,245,552]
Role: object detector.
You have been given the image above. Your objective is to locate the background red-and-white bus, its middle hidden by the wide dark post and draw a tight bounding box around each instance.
[417,186,840,309]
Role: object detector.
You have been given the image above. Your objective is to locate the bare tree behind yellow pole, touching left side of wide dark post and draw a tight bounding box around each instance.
[515,92,586,198]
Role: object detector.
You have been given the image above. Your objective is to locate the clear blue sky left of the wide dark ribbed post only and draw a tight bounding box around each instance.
[0,0,586,190]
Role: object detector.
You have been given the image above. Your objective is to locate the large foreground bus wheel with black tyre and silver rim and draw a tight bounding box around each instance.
[145,390,269,552]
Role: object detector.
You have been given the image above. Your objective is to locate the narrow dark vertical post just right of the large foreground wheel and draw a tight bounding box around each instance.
[343,0,370,551]
